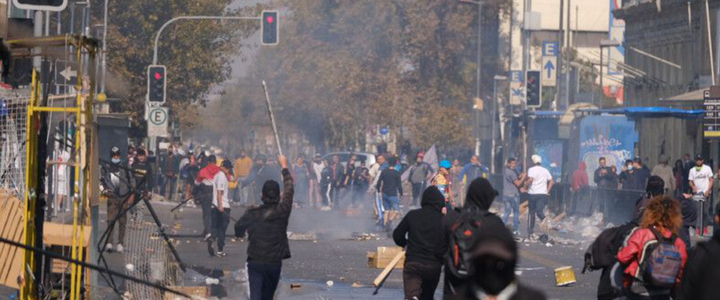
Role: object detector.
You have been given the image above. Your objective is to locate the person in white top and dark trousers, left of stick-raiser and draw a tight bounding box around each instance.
[208,160,233,257]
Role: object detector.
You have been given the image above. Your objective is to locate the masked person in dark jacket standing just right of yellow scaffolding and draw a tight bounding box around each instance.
[100,146,135,252]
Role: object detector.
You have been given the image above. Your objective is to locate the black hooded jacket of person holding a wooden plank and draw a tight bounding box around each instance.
[393,186,447,266]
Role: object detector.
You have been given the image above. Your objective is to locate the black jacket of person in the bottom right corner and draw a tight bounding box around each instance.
[677,232,720,300]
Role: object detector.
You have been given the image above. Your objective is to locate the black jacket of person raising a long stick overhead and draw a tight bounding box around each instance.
[235,169,295,263]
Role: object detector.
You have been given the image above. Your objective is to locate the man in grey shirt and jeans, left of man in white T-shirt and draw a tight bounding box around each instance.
[503,157,525,236]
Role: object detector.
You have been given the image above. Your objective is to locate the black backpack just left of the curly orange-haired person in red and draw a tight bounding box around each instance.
[582,222,637,274]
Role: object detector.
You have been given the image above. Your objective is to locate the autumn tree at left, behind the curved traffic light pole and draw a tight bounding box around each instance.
[93,0,259,130]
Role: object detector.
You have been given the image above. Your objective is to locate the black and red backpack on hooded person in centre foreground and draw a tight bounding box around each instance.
[446,209,492,279]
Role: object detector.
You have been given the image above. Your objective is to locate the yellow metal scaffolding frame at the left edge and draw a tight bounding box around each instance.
[5,35,98,300]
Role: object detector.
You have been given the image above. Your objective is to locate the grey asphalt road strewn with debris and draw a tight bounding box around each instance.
[0,198,599,299]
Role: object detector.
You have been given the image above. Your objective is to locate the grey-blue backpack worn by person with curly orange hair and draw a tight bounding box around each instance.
[639,228,683,288]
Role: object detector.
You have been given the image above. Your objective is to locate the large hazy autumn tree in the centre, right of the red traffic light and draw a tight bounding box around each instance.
[214,0,509,148]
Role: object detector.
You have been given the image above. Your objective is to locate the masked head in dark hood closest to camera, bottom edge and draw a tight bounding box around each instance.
[450,218,545,300]
